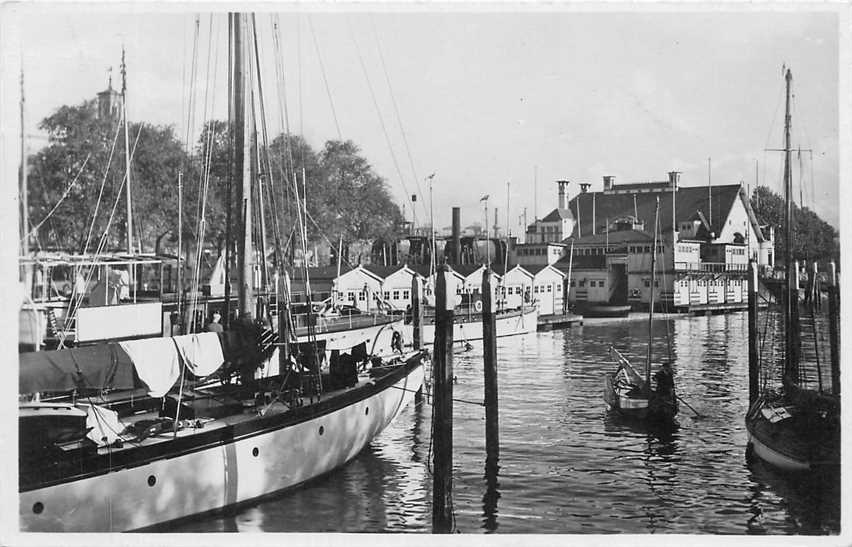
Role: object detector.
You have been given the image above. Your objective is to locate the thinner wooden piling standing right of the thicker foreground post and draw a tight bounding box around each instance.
[482,266,500,459]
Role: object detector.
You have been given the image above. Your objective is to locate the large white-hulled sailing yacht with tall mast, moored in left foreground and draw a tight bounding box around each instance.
[18,14,428,532]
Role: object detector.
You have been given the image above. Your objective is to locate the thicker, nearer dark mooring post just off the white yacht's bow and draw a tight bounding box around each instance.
[432,264,455,534]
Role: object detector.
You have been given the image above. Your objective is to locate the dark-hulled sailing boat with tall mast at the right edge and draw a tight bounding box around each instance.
[745,69,841,471]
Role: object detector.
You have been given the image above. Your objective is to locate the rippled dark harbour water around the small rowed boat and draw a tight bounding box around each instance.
[169,313,840,534]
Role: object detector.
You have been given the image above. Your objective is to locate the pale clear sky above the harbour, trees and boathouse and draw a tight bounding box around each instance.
[3,3,841,239]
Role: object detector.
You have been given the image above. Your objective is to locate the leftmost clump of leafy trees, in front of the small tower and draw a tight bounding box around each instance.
[28,101,194,252]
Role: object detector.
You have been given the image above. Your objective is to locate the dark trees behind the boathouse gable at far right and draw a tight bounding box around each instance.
[751,186,840,263]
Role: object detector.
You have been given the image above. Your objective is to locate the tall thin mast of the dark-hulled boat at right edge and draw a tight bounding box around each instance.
[784,69,799,387]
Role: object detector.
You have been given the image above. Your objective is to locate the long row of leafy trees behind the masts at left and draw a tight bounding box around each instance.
[23,101,403,266]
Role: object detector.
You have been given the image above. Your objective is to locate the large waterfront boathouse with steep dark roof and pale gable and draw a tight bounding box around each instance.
[555,172,774,311]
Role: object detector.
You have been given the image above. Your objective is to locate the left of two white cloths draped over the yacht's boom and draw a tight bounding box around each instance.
[119,338,180,397]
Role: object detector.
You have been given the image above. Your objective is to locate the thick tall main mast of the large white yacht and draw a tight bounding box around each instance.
[231,13,254,317]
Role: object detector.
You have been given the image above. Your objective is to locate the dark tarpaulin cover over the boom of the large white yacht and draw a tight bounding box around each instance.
[18,344,136,394]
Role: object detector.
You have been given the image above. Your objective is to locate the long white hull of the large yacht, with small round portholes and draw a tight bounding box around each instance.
[20,360,424,532]
